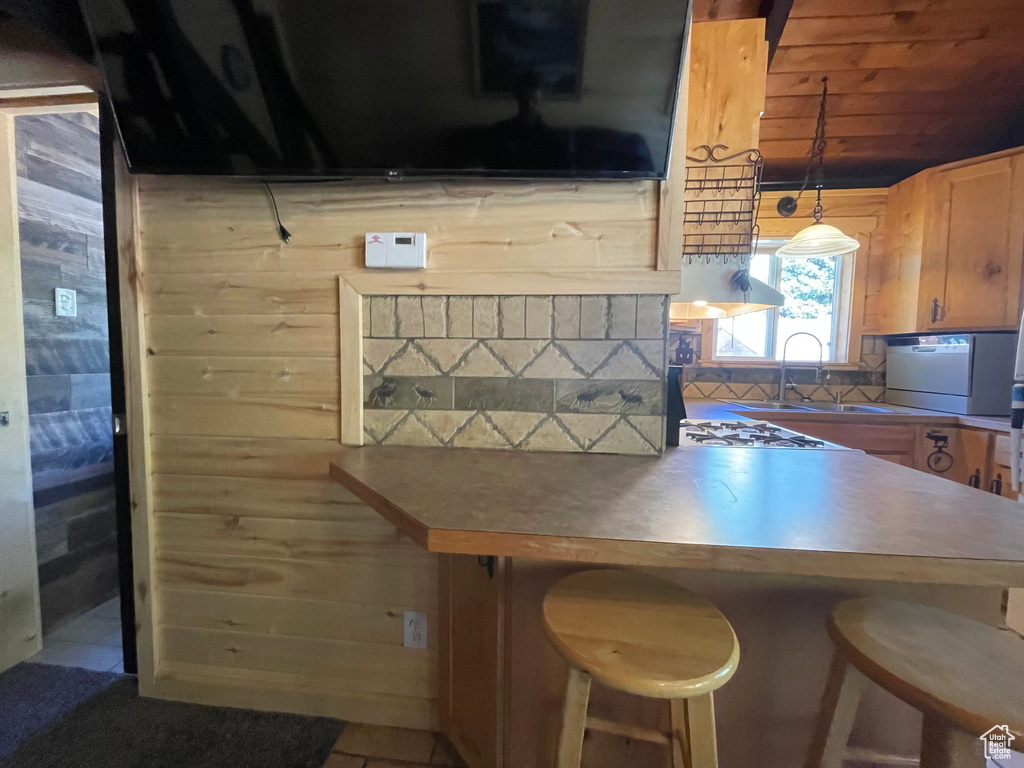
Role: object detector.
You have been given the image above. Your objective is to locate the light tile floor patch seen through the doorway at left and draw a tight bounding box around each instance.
[29,597,124,673]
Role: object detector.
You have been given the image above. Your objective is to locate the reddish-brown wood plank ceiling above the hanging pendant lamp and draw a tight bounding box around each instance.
[753,0,1024,186]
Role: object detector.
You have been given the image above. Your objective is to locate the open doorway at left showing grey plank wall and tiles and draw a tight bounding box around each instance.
[0,94,135,673]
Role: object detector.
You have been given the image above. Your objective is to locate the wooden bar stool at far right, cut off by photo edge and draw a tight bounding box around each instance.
[805,598,1024,768]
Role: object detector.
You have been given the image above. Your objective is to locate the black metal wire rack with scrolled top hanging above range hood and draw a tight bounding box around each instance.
[682,144,764,262]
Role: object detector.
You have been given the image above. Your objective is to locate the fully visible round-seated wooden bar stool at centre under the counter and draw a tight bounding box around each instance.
[544,570,739,768]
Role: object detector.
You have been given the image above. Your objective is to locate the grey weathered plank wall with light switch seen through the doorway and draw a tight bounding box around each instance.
[14,112,118,632]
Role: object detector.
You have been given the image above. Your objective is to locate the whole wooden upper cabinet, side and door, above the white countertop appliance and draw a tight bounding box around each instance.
[879,148,1024,334]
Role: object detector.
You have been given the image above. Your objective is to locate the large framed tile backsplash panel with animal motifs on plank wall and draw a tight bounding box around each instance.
[362,294,669,456]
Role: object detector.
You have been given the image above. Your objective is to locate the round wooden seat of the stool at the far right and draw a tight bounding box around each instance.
[827,598,1024,744]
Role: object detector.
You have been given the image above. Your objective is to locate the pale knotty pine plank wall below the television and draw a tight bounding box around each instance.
[137,177,657,727]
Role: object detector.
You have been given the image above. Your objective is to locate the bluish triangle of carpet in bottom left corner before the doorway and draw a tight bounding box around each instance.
[0,664,121,765]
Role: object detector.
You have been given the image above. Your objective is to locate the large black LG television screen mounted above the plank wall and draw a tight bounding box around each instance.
[82,0,690,178]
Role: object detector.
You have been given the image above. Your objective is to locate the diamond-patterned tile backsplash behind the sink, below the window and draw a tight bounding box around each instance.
[669,331,886,402]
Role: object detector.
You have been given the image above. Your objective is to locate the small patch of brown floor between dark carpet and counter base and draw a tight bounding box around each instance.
[324,723,466,768]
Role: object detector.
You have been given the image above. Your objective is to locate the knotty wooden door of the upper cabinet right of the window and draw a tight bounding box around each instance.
[919,154,1024,329]
